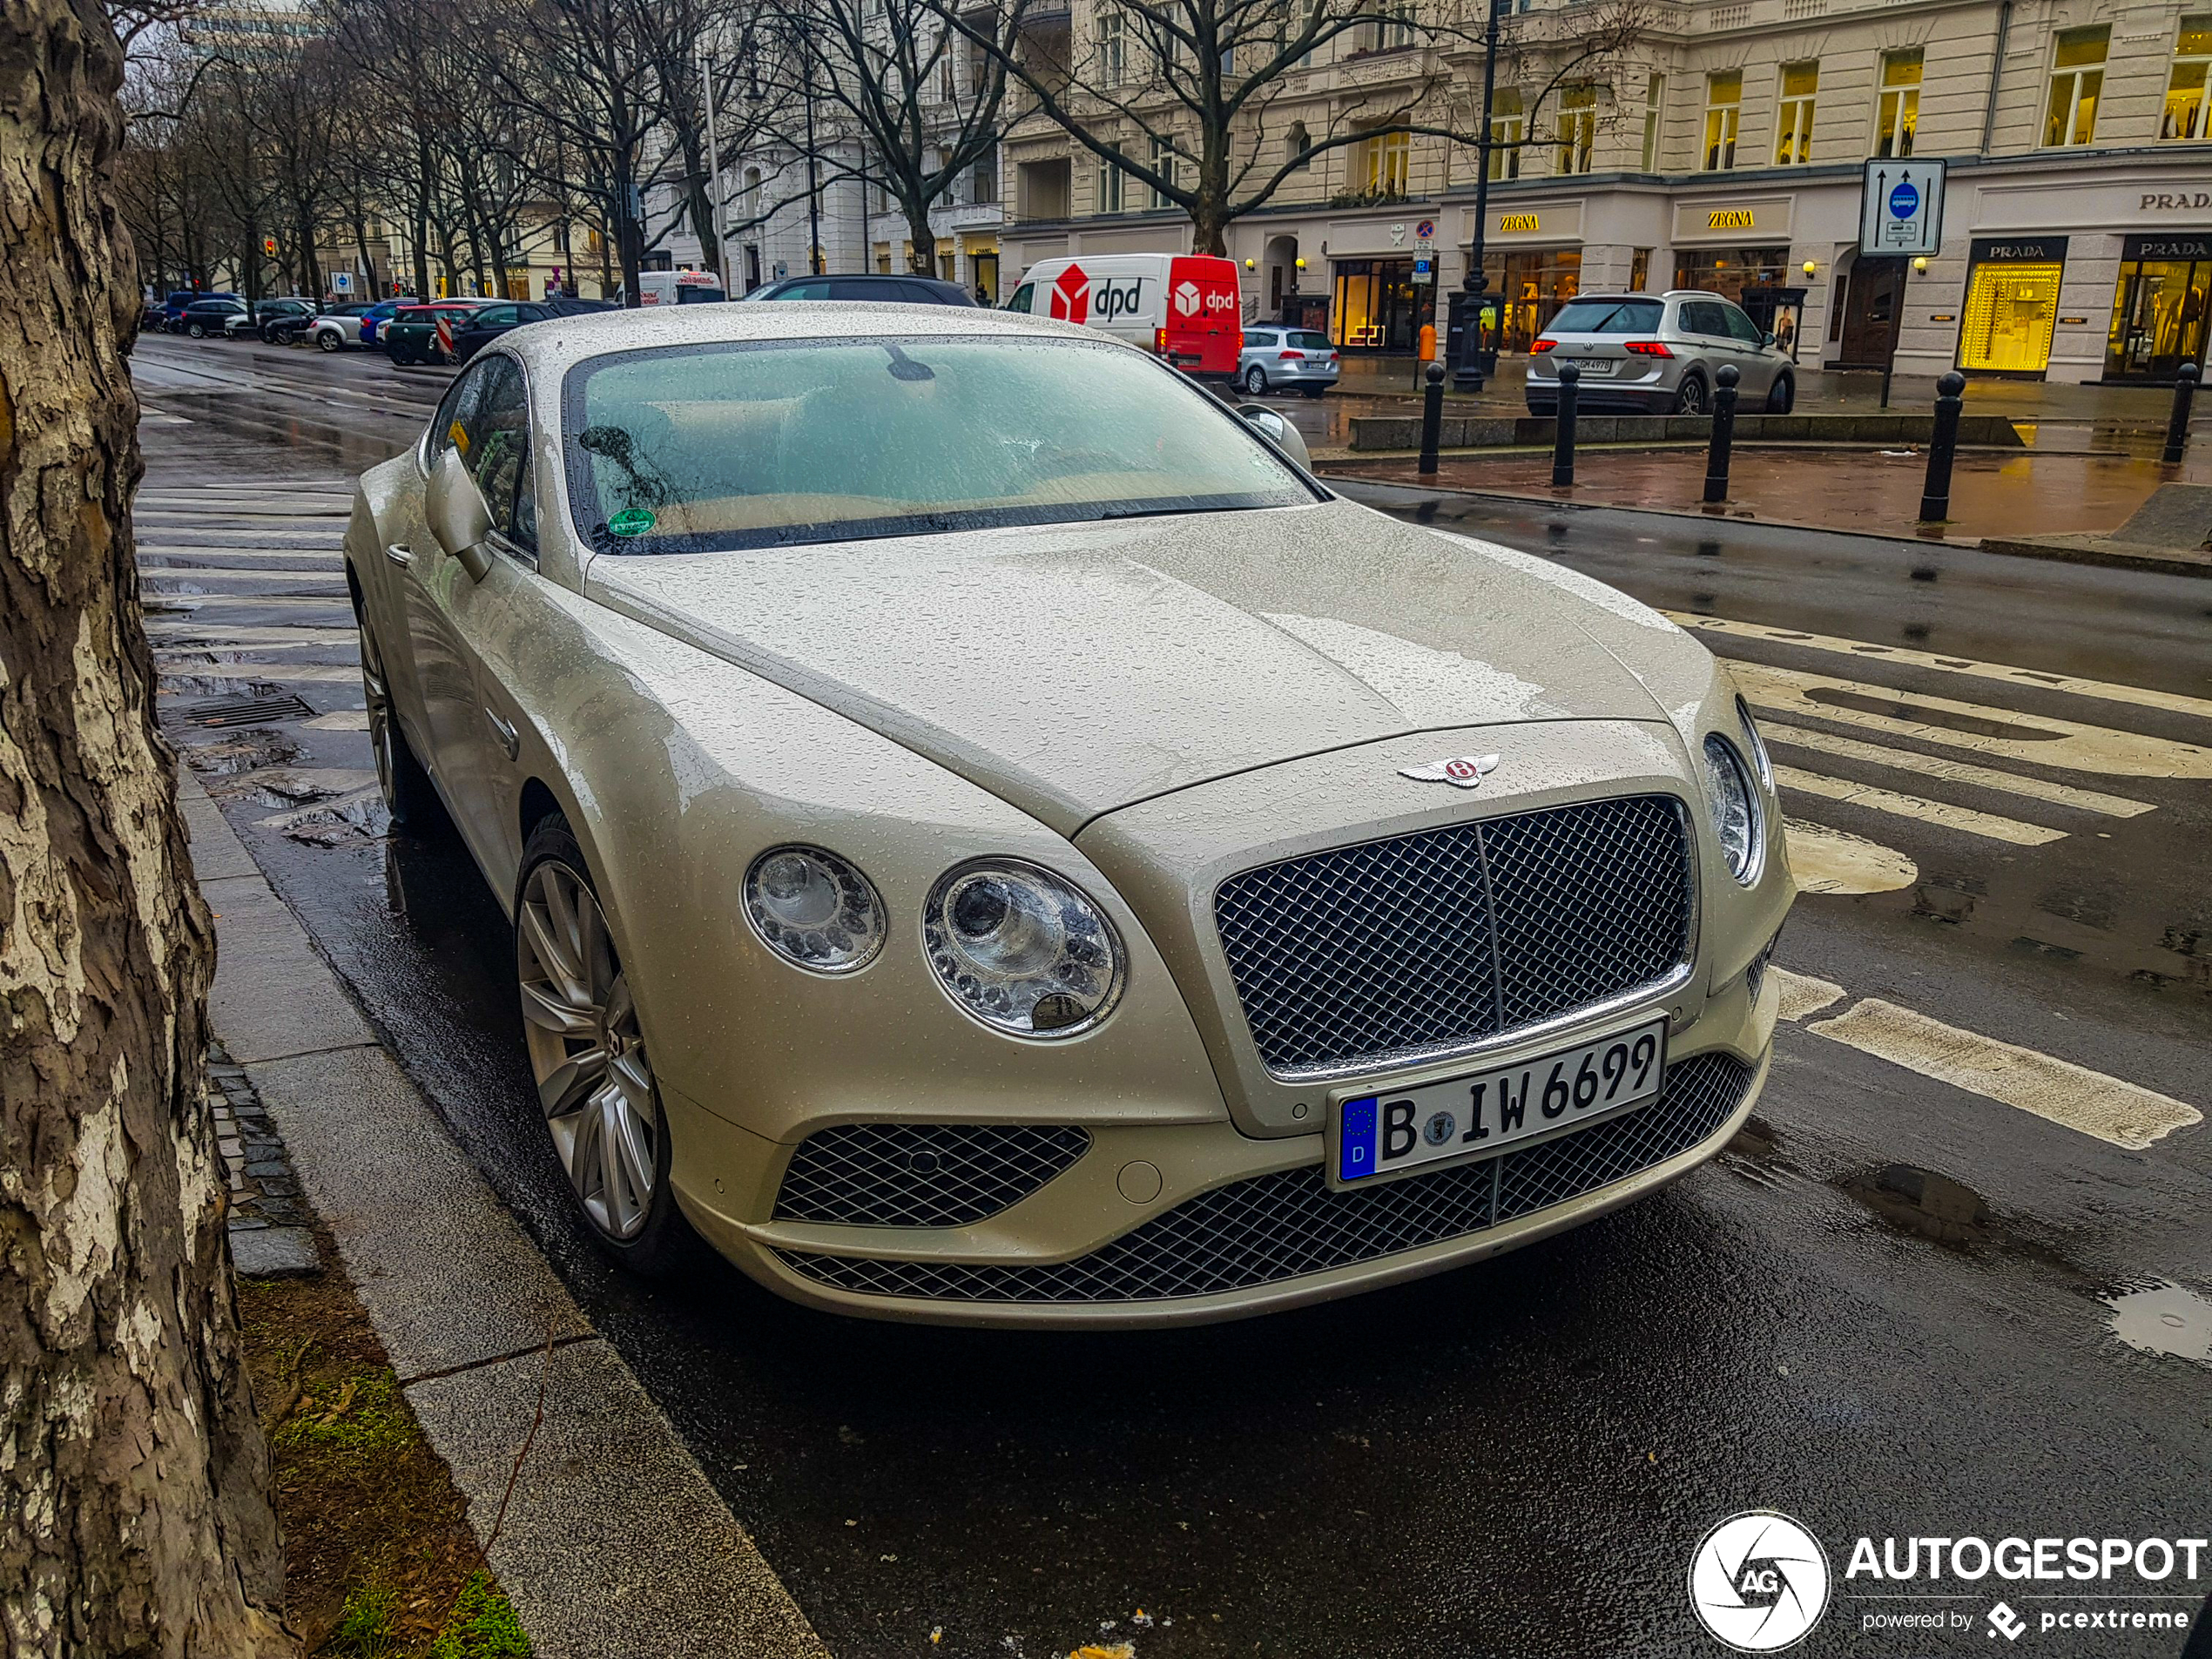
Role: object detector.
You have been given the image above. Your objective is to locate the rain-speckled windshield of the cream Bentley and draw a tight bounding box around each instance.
[562,336,1316,553]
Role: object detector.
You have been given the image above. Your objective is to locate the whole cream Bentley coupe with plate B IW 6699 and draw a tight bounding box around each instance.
[345,303,1794,1325]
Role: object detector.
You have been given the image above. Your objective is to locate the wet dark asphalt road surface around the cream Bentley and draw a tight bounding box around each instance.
[137,341,2212,1659]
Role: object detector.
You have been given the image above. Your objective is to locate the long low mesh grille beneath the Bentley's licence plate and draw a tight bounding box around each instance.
[777,1053,1757,1303]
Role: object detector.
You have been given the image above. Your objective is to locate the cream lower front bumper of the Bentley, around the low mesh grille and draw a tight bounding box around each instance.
[668,975,1778,1330]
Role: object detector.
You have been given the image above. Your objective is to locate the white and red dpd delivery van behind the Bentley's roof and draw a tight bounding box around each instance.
[1007,254,1243,381]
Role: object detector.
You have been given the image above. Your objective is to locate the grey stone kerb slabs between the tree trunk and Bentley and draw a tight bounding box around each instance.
[177,765,827,1659]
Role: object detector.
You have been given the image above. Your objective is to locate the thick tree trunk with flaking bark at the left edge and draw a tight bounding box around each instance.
[0,0,294,1659]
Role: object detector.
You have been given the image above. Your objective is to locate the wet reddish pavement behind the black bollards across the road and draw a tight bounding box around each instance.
[1314,445,2212,540]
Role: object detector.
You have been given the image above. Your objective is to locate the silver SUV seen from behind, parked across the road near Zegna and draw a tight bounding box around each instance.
[1528,287,1796,416]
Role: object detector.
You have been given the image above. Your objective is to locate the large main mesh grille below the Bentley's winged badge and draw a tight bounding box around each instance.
[1214,794,1696,1082]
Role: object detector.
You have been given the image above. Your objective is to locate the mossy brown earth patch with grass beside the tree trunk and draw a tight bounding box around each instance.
[239,1241,531,1659]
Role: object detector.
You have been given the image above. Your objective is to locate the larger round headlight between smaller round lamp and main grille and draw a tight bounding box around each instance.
[922,863,1122,1037]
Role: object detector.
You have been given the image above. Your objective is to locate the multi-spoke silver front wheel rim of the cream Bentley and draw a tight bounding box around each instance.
[516,859,661,1238]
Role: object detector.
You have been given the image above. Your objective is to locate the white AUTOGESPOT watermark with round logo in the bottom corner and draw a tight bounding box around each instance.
[1690,1508,2212,1652]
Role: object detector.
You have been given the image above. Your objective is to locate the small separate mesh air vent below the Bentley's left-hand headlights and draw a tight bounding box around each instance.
[774,1123,1090,1228]
